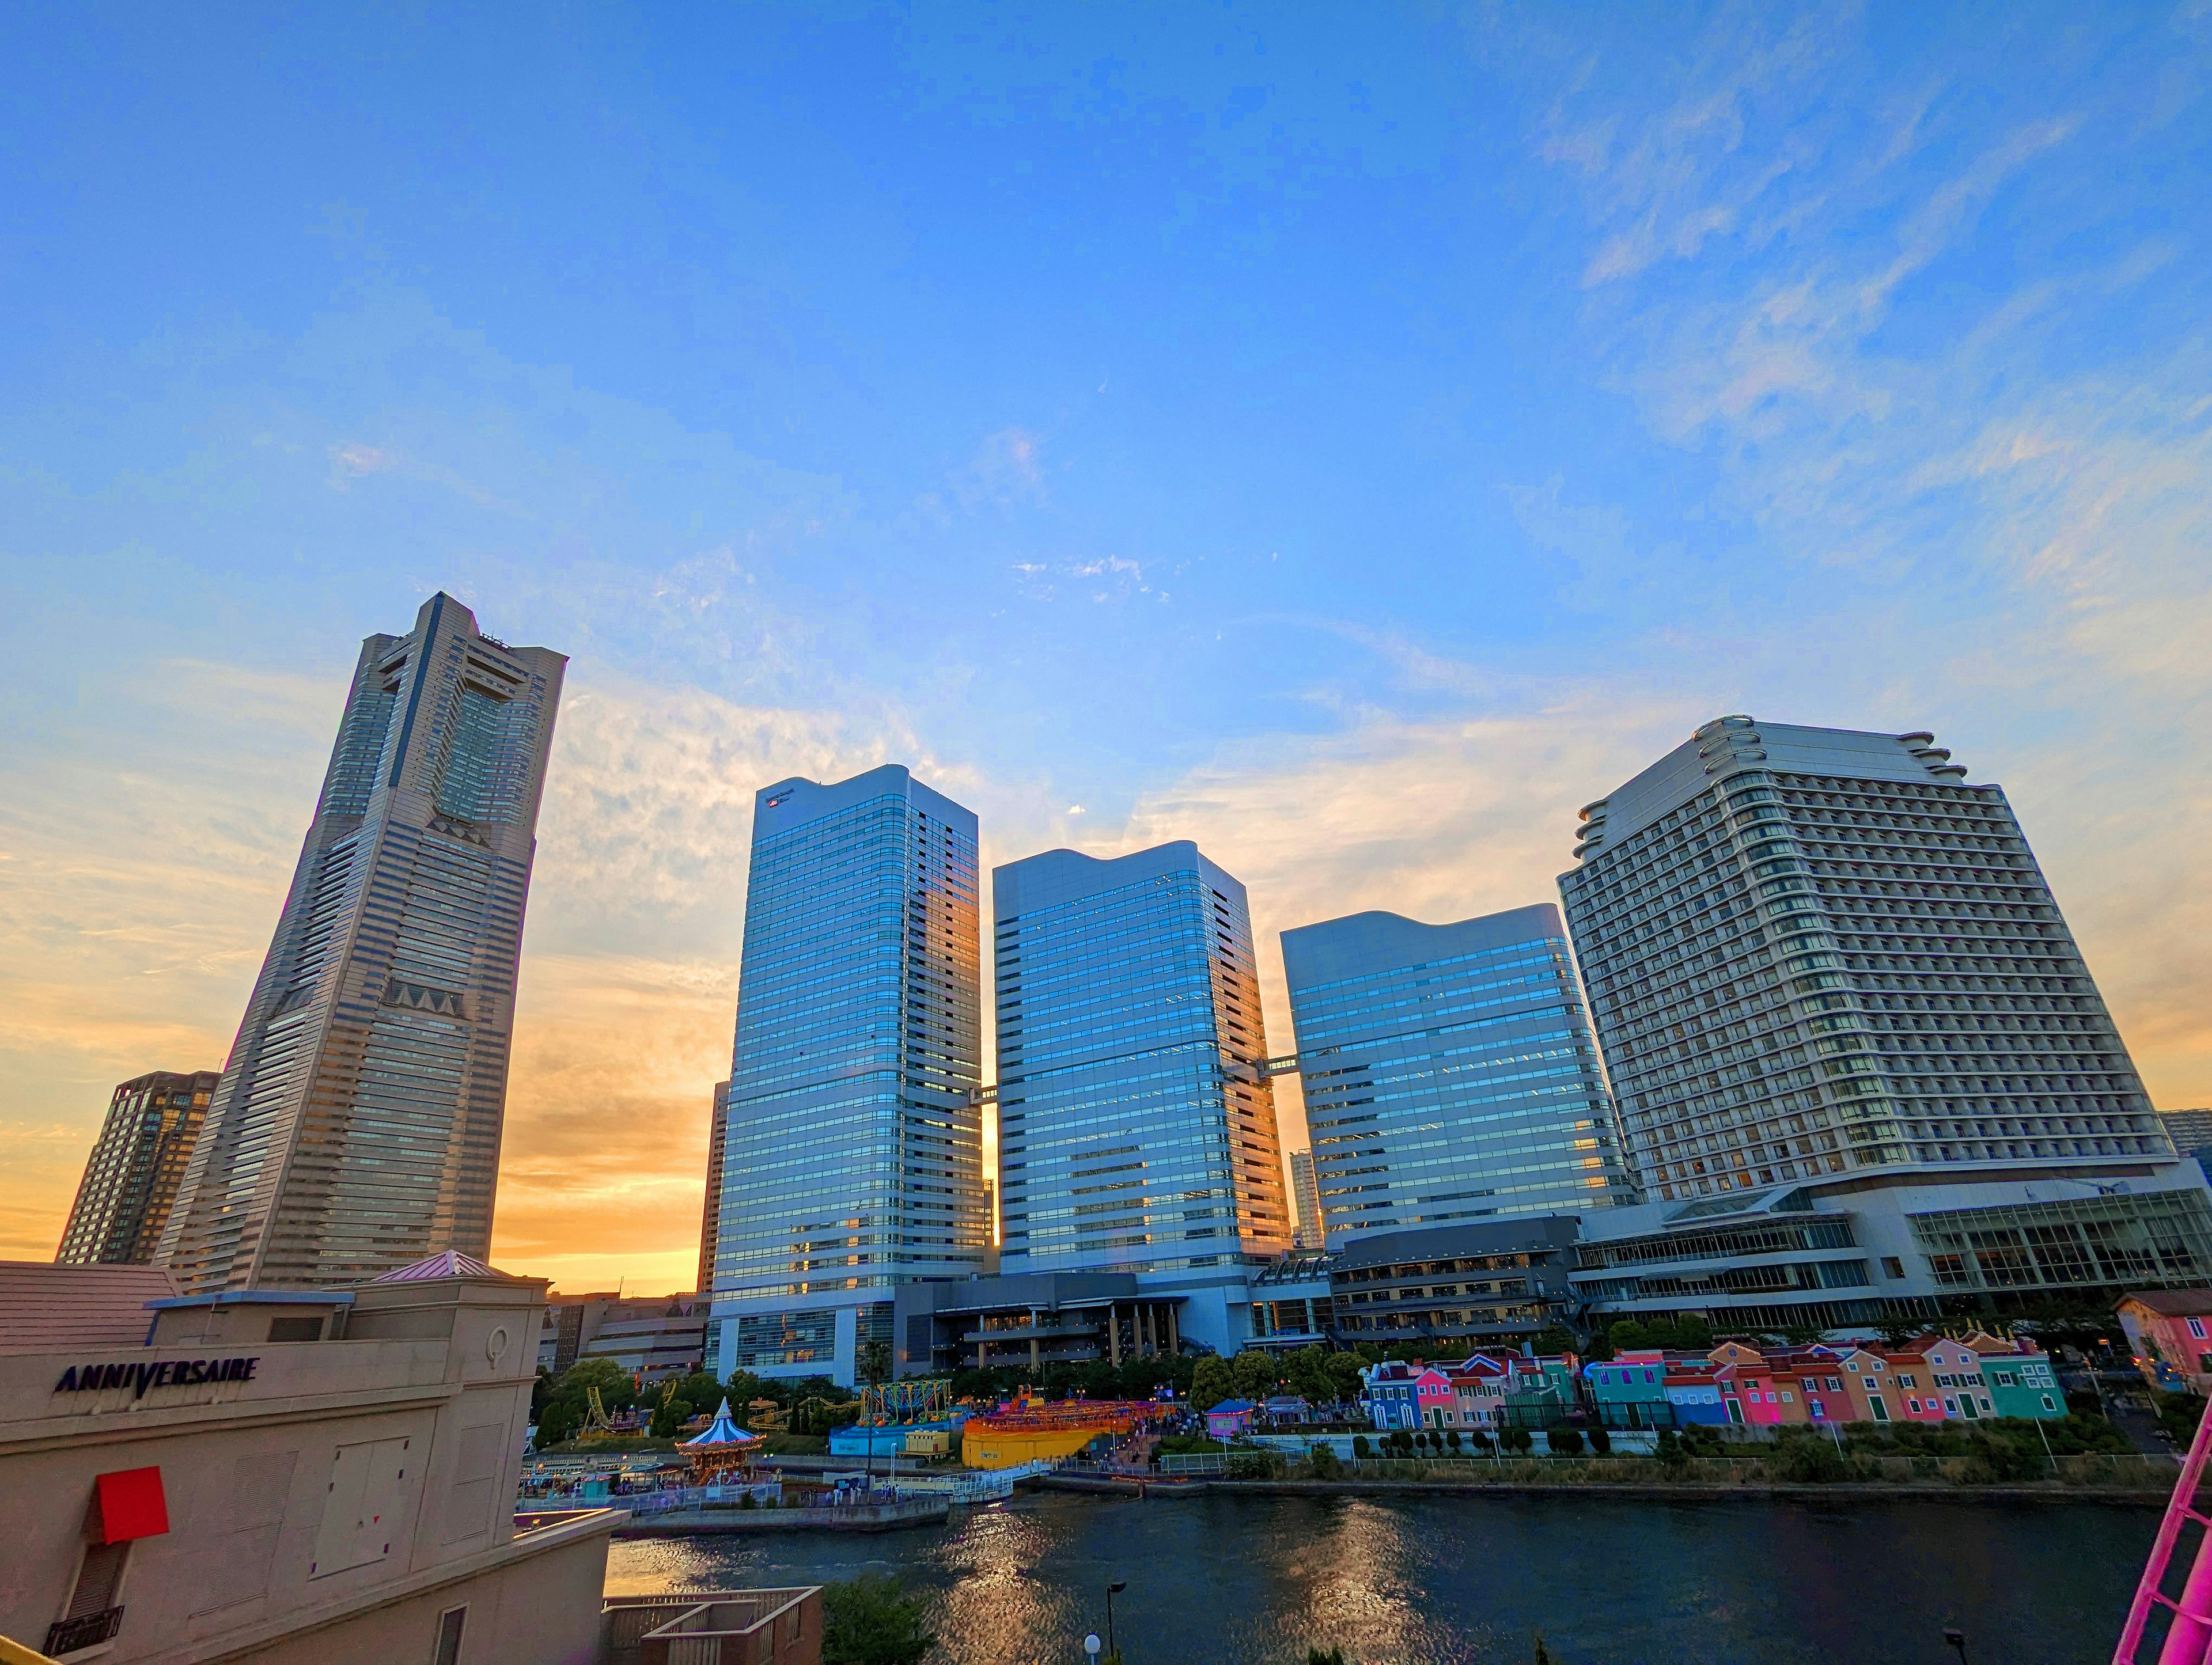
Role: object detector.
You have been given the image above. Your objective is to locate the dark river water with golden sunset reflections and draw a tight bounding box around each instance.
[606,1493,2159,1665]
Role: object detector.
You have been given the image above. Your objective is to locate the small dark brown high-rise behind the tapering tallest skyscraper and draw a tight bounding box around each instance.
[53,1070,224,1265]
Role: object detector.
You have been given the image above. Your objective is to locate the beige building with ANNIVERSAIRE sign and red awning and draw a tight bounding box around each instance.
[0,1254,624,1665]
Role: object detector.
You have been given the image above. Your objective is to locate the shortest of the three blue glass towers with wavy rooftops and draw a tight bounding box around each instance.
[1283,902,1635,1241]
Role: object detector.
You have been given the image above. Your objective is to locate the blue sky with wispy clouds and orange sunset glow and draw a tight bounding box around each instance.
[0,0,2212,1285]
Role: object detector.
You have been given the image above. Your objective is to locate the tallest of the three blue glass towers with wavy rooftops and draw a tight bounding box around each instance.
[710,765,991,1382]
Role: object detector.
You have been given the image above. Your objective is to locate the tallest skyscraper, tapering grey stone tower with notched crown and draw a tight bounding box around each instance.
[159,593,569,1291]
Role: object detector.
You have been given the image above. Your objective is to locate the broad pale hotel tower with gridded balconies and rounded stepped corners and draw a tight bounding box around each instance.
[1559,716,2212,1320]
